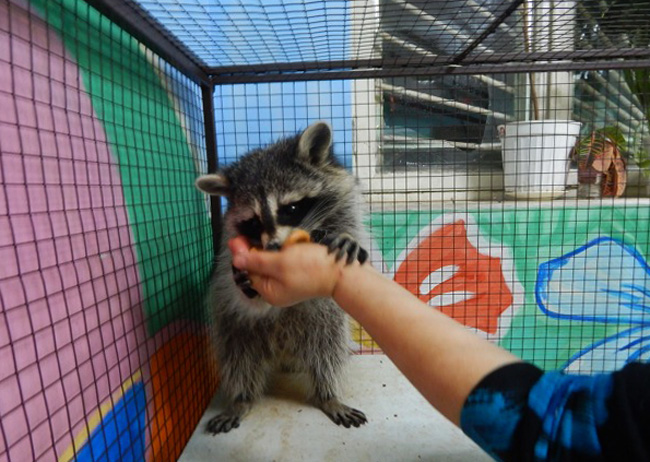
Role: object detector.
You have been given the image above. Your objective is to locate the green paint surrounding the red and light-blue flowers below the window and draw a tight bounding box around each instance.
[370,202,650,369]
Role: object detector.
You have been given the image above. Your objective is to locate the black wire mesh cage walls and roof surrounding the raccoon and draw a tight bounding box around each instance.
[0,0,650,461]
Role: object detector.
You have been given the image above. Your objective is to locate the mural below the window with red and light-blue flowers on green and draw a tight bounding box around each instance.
[356,205,650,373]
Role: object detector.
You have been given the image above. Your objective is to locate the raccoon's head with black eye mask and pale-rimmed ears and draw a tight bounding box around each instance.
[196,123,356,250]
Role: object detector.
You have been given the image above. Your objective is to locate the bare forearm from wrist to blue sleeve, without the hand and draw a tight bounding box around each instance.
[333,253,519,425]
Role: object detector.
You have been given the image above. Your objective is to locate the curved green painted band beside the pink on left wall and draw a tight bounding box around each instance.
[31,0,212,334]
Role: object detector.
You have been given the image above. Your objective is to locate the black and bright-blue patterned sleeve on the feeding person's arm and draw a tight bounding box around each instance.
[461,363,650,462]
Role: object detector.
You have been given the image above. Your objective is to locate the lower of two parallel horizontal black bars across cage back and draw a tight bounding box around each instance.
[213,59,650,85]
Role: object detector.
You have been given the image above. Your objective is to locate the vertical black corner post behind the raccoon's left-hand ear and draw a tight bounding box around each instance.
[201,84,221,258]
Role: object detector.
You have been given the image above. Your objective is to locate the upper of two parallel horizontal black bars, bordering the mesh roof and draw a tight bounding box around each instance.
[206,48,650,84]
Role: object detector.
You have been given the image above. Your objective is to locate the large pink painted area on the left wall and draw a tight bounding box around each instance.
[0,0,147,460]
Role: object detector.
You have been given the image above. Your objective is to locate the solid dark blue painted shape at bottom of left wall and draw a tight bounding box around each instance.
[75,382,147,462]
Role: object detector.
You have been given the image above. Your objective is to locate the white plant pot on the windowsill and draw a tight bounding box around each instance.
[499,120,580,199]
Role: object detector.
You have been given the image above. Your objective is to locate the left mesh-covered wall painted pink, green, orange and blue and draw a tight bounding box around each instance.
[0,0,216,461]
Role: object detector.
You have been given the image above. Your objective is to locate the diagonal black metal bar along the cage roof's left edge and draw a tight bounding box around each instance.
[86,0,210,84]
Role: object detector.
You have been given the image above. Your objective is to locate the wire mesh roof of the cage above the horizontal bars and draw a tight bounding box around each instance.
[138,0,650,68]
